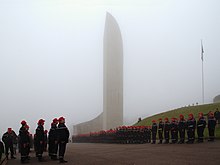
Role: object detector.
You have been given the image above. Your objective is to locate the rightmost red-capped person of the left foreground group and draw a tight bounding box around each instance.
[57,117,69,163]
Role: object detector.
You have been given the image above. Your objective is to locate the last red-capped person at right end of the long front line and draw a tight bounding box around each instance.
[208,112,216,142]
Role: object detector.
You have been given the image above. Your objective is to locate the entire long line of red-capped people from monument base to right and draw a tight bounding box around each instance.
[72,112,216,144]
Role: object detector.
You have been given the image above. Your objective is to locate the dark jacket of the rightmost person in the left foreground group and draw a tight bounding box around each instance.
[57,123,70,143]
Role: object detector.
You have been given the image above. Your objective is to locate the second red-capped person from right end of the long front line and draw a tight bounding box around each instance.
[197,112,206,143]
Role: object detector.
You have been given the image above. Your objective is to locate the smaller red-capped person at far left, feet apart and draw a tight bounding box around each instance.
[2,128,15,159]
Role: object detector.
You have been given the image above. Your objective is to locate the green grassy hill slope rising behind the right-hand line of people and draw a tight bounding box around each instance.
[134,103,220,138]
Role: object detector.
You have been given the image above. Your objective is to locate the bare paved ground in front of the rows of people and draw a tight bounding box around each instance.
[8,141,220,165]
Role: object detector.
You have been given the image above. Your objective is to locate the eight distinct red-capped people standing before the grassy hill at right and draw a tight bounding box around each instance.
[152,112,216,144]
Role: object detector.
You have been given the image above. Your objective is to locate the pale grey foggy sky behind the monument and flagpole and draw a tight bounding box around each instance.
[0,0,220,136]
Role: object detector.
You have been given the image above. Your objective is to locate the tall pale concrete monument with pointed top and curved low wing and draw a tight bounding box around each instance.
[73,13,123,134]
